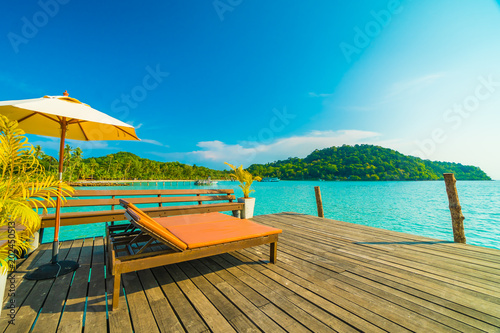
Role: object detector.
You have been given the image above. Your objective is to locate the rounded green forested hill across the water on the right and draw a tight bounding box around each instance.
[248,145,491,180]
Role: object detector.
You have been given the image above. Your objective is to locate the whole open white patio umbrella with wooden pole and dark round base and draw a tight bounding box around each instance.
[0,91,139,280]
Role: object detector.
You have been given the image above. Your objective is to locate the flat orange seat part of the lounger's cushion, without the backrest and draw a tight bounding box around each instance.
[168,214,281,249]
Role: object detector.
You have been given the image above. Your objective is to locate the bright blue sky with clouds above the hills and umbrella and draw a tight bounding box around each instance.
[0,0,500,179]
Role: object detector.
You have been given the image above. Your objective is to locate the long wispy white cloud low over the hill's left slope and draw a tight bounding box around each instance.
[154,130,380,169]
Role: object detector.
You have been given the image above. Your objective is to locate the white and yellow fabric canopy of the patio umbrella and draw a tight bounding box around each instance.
[0,96,139,141]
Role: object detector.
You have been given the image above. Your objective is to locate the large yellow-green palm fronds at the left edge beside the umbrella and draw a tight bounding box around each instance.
[0,115,73,312]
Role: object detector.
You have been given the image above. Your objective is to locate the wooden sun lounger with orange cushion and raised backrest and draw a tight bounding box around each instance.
[106,199,281,309]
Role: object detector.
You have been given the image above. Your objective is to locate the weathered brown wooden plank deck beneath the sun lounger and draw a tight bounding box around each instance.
[0,213,500,333]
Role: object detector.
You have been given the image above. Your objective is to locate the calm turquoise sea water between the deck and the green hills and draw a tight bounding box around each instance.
[43,181,500,249]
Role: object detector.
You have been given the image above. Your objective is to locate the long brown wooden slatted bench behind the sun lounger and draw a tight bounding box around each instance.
[40,189,244,238]
